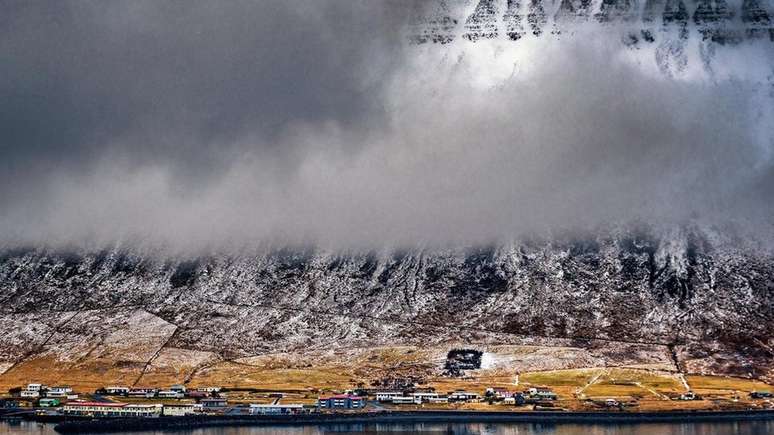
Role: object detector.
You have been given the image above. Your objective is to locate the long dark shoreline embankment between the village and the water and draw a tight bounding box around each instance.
[54,410,774,433]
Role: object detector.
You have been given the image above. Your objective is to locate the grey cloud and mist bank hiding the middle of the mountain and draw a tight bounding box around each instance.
[0,0,774,252]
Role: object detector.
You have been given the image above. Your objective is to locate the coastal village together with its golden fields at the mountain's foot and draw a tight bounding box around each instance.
[0,346,774,428]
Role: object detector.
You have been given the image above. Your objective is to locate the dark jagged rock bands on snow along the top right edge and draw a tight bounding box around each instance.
[411,0,774,44]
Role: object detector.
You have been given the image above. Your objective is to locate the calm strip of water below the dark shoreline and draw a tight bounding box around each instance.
[0,420,774,435]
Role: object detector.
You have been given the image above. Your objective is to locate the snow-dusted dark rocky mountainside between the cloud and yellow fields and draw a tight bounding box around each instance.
[0,228,774,379]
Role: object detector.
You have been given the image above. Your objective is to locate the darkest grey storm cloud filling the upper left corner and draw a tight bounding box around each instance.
[0,0,406,201]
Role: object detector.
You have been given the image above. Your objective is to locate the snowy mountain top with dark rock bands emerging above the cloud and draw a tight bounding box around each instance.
[408,0,774,77]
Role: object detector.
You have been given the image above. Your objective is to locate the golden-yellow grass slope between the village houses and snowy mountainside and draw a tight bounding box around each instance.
[0,346,774,411]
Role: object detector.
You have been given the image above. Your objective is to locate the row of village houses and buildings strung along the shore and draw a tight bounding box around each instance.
[0,383,774,418]
